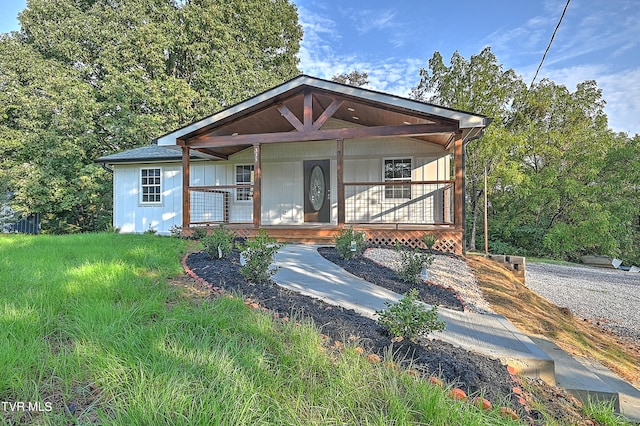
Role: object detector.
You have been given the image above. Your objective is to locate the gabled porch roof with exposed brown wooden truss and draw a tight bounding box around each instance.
[156,75,492,159]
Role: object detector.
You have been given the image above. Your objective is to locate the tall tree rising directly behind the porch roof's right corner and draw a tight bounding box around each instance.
[411,47,525,250]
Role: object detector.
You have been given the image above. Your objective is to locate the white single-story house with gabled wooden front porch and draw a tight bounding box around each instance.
[96,75,491,253]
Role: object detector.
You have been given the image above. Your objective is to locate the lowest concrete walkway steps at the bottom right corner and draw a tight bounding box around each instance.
[531,337,640,422]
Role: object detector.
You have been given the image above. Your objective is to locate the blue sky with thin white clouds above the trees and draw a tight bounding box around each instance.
[0,0,640,135]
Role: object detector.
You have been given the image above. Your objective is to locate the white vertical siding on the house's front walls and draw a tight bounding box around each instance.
[113,129,451,234]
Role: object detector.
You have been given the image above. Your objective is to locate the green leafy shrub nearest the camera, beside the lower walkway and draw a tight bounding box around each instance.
[376,288,445,340]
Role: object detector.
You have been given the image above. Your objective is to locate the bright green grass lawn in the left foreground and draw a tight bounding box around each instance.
[0,234,608,425]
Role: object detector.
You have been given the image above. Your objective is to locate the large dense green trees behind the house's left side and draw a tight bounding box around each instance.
[0,0,302,232]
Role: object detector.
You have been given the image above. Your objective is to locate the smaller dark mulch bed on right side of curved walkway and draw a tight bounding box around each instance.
[318,247,464,311]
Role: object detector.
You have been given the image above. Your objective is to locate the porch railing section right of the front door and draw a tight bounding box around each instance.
[344,181,454,225]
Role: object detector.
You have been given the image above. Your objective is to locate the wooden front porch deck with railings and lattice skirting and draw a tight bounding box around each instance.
[184,180,463,254]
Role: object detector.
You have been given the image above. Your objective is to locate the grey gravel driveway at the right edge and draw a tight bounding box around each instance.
[526,263,640,341]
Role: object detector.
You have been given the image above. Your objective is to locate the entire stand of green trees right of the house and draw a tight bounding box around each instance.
[413,48,640,264]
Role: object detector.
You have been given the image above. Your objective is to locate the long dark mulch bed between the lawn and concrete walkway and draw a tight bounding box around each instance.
[186,250,525,415]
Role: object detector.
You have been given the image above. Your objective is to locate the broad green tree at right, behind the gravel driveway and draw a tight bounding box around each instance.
[494,80,632,260]
